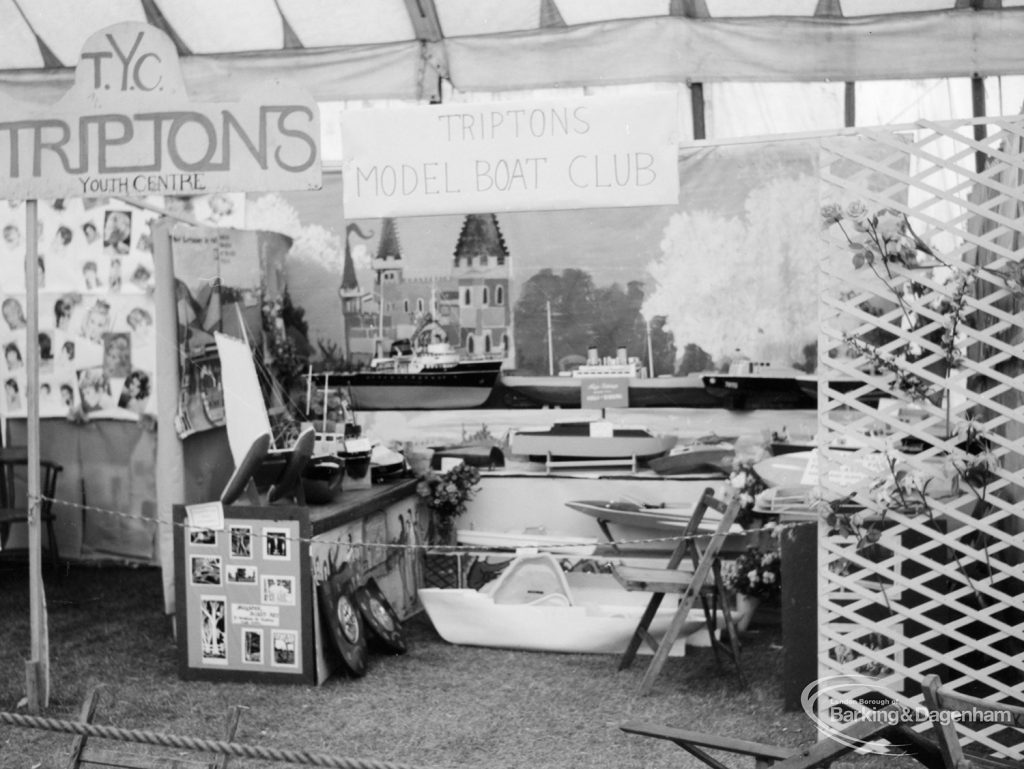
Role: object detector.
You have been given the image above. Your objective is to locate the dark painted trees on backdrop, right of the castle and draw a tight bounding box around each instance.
[515,268,676,374]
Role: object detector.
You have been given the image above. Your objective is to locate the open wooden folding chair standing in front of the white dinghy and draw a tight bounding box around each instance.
[612,487,746,694]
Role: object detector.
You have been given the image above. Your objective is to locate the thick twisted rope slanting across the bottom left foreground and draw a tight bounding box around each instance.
[0,711,416,769]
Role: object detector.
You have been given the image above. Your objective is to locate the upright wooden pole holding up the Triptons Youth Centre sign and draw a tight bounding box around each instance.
[25,200,47,714]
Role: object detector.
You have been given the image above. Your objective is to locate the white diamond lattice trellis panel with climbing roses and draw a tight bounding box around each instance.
[818,118,1024,759]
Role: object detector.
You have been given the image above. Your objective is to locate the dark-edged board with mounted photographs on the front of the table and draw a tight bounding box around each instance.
[174,505,313,681]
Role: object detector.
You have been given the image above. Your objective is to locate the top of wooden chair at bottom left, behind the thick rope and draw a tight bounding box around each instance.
[68,684,242,769]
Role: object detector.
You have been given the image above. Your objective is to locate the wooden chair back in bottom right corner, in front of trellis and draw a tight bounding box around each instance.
[921,675,1024,769]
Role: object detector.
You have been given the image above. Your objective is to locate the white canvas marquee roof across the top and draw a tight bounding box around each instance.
[0,0,1024,110]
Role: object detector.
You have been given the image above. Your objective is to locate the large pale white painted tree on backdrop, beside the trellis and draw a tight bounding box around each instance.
[643,175,821,366]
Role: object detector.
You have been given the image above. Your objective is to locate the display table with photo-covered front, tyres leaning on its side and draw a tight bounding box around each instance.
[174,479,426,684]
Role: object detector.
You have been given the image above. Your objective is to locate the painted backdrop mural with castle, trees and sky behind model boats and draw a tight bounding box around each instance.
[256,141,820,382]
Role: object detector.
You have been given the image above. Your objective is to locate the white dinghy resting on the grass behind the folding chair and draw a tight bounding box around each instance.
[419,553,723,656]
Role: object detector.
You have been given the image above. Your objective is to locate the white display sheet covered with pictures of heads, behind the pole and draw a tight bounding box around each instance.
[0,200,156,419]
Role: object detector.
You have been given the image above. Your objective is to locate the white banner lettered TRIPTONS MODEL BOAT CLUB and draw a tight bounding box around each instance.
[341,94,679,218]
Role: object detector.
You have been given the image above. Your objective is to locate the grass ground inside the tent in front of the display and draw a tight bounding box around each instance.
[0,565,929,769]
